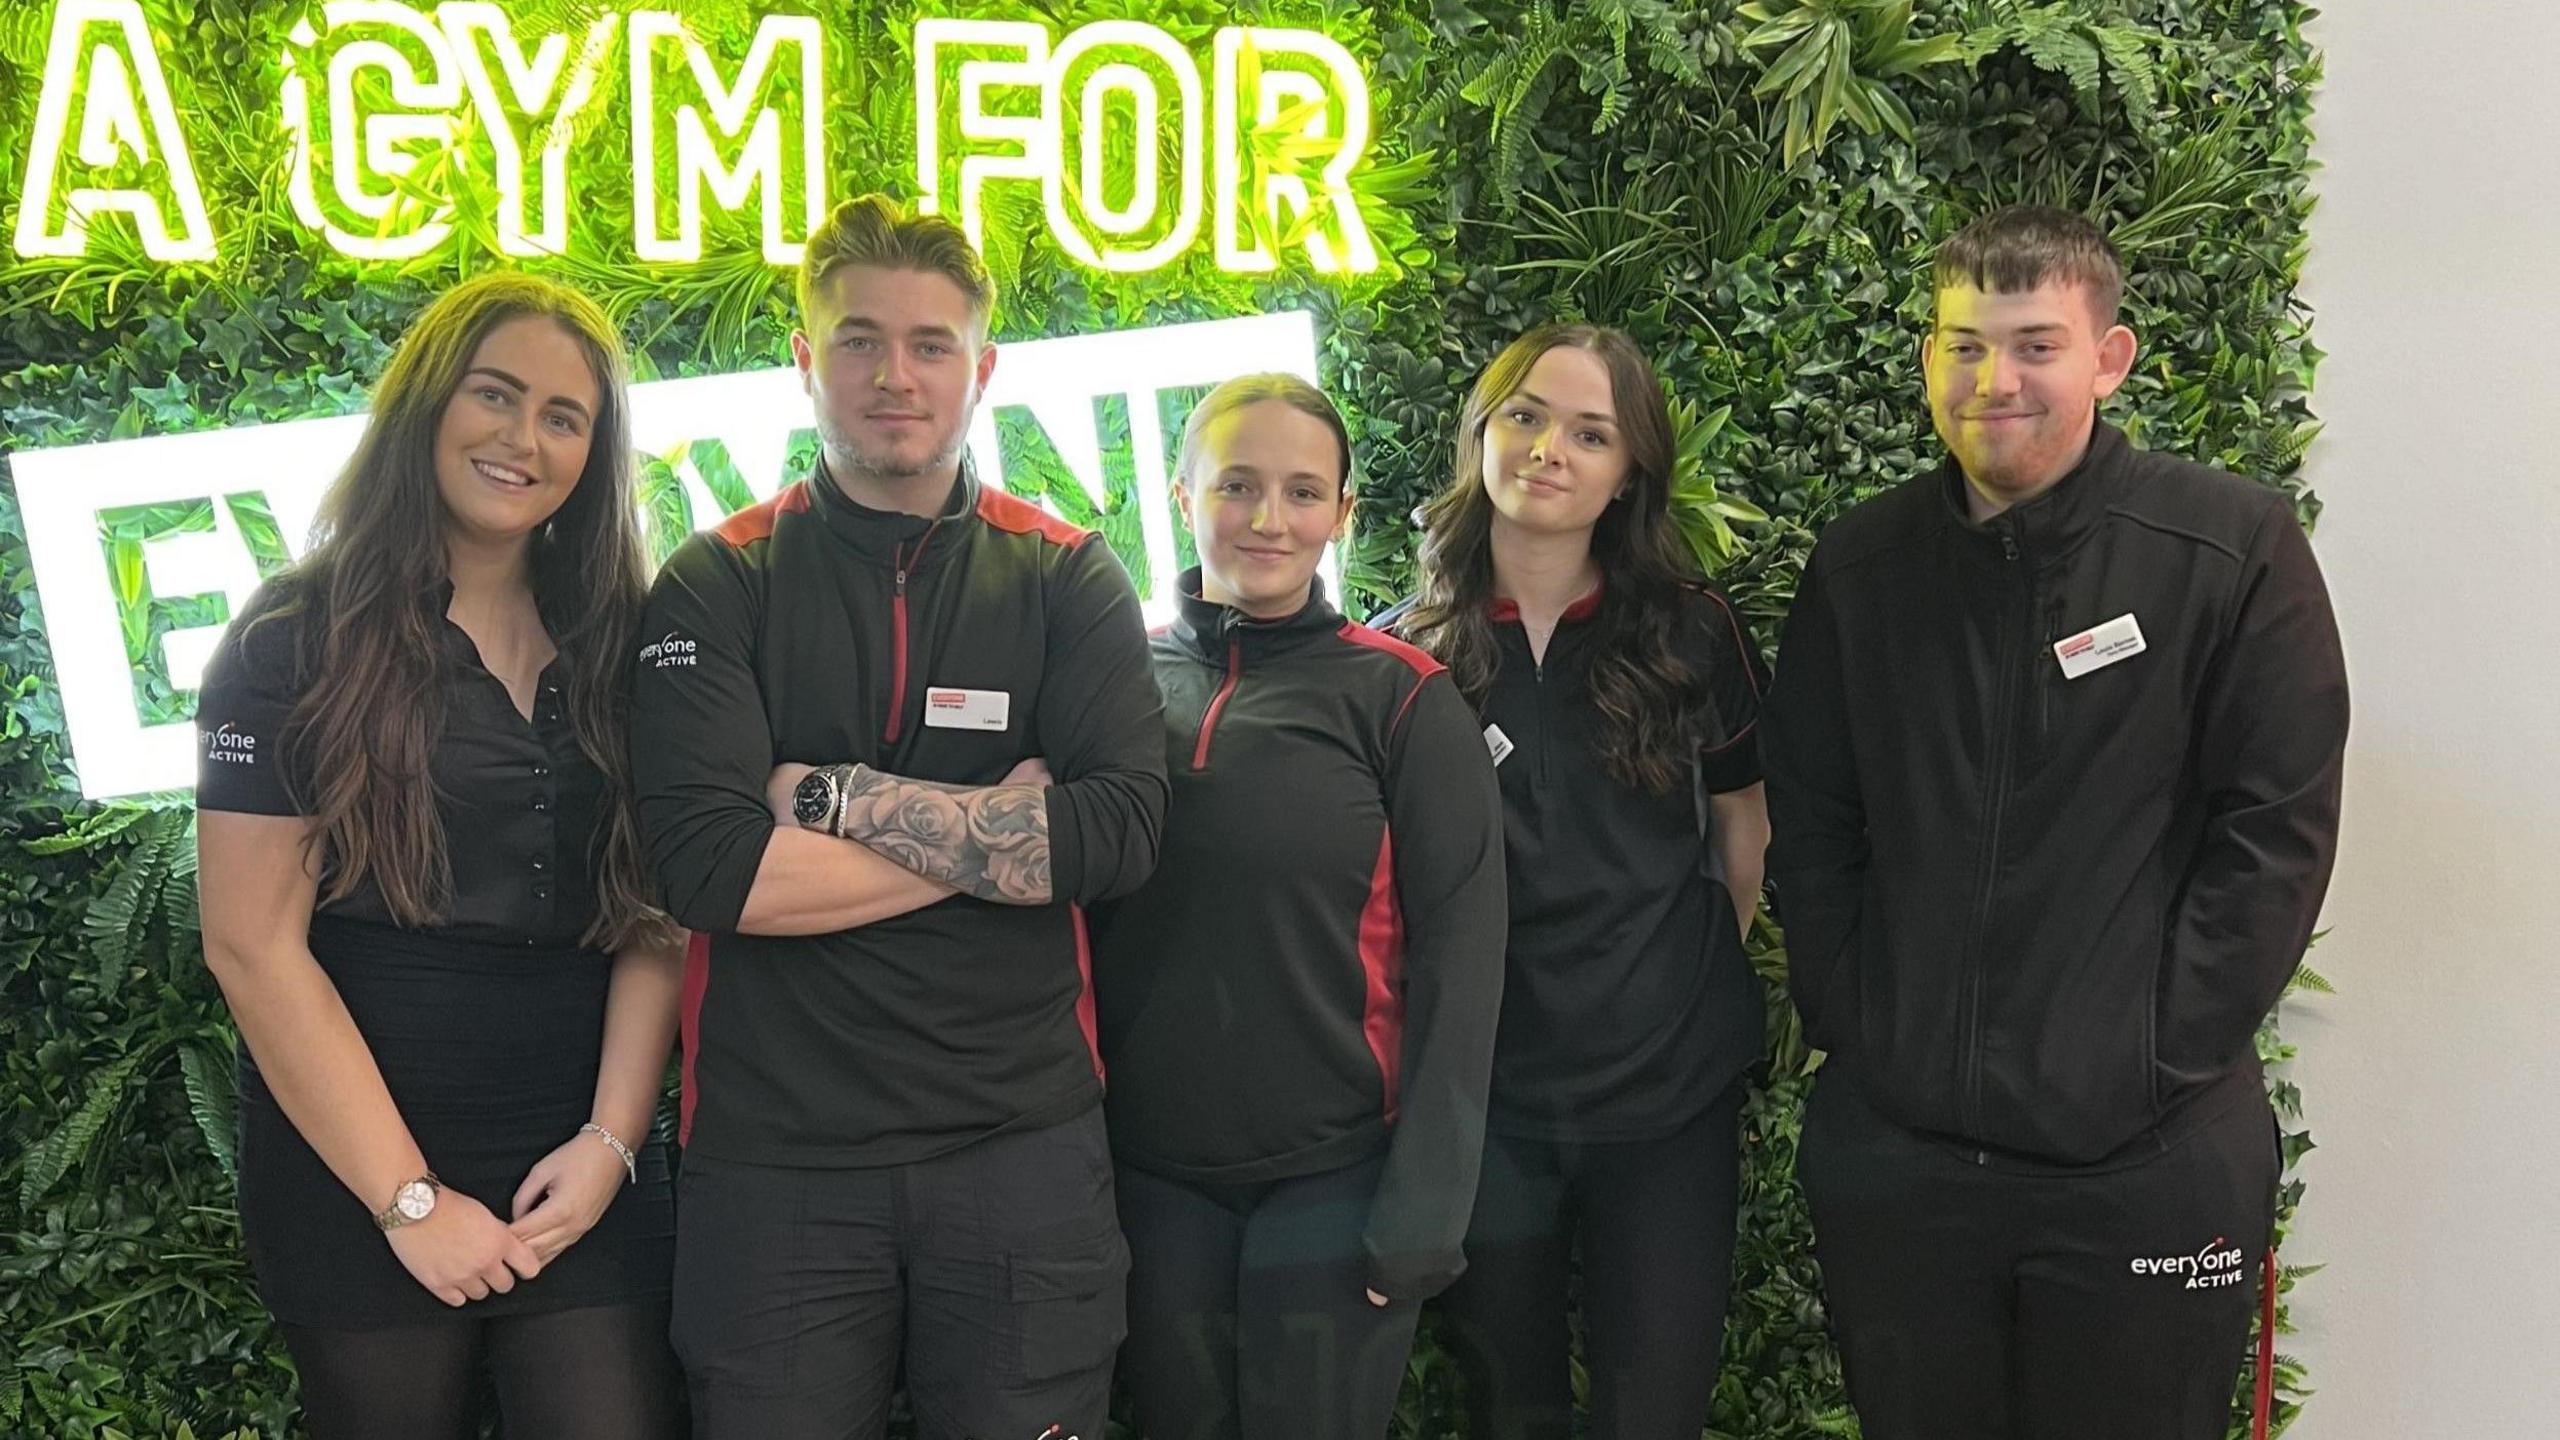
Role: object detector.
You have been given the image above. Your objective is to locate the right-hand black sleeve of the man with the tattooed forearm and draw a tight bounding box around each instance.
[1039,536,1170,904]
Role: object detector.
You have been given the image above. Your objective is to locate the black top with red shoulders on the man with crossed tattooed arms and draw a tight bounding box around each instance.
[632,458,1165,1166]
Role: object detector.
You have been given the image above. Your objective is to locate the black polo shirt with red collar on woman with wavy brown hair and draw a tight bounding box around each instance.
[1482,576,1764,1140]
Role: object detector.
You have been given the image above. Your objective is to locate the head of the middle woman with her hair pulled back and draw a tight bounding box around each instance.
[1172,400,1352,620]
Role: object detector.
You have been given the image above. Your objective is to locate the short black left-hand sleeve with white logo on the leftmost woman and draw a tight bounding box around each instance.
[195,582,302,815]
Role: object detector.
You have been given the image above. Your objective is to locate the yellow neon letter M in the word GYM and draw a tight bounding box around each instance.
[630,10,827,264]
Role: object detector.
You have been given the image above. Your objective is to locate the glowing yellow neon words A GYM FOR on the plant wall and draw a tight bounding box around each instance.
[15,0,1377,274]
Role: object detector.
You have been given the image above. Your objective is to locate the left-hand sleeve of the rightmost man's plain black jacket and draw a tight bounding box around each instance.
[1761,548,1869,1051]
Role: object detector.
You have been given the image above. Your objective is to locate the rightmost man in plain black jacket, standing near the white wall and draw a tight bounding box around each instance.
[1764,208,2348,1440]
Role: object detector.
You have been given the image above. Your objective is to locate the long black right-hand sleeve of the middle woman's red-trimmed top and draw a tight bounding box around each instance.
[1362,671,1510,1302]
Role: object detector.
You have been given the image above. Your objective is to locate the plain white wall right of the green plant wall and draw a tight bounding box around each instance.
[2286,0,2560,1440]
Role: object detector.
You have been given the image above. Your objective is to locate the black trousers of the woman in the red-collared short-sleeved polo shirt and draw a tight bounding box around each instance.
[1441,1084,1743,1440]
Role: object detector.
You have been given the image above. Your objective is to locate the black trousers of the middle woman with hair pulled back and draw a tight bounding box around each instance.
[1119,1156,1421,1440]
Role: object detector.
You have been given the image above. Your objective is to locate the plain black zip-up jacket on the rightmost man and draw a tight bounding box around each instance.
[1764,423,2348,1166]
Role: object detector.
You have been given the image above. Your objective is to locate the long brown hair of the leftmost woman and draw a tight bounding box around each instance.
[252,272,668,948]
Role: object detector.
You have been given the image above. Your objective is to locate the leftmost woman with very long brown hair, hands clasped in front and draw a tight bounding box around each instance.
[197,274,681,1440]
